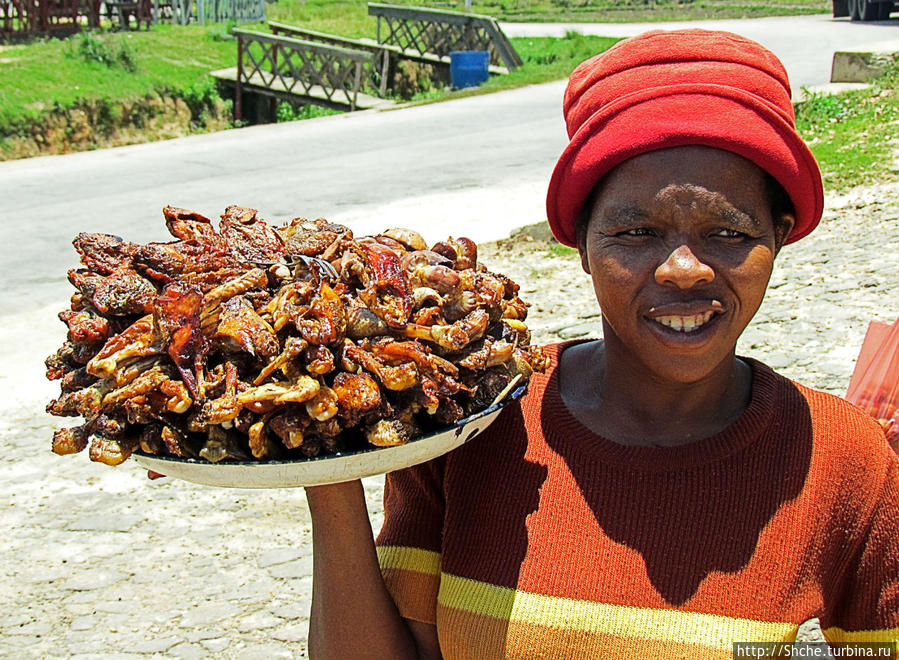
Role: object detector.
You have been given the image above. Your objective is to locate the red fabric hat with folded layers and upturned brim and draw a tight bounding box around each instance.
[546,30,824,247]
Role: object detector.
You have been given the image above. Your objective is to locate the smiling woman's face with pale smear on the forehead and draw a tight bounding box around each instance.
[580,146,789,383]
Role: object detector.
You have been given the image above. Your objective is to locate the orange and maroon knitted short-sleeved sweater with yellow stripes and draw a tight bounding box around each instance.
[377,344,899,660]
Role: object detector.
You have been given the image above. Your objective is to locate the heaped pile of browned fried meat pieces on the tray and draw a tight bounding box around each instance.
[46,206,547,465]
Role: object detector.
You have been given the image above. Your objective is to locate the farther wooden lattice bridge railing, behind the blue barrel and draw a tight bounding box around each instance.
[368,3,522,70]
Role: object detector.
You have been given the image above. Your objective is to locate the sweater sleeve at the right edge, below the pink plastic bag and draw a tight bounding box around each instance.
[827,444,899,642]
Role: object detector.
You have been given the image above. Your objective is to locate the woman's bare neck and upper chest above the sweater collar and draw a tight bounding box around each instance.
[559,340,752,446]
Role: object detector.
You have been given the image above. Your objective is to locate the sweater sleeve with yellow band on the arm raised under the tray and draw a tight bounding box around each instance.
[376,458,445,623]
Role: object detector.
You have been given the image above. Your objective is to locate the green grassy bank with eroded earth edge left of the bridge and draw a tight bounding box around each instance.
[0,25,236,159]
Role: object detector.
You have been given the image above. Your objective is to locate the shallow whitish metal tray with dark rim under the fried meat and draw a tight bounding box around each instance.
[132,385,527,488]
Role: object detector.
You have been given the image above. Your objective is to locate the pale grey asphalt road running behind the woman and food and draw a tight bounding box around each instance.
[0,16,899,418]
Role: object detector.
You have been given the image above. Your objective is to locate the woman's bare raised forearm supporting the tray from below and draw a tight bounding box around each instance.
[306,480,440,659]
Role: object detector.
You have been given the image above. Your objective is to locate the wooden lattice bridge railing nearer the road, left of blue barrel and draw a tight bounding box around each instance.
[234,29,371,120]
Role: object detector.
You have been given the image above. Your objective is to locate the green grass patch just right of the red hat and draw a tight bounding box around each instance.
[796,72,899,191]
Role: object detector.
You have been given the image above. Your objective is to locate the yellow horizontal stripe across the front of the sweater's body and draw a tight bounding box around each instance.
[438,573,798,650]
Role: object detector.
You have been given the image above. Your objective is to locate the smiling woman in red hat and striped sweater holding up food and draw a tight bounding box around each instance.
[307,30,899,658]
